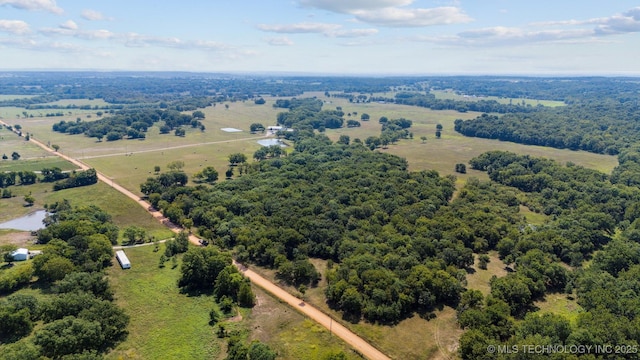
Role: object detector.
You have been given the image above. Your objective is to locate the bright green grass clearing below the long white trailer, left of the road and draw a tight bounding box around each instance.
[106,246,223,360]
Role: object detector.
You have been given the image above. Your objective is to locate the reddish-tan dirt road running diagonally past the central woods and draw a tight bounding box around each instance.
[0,120,390,360]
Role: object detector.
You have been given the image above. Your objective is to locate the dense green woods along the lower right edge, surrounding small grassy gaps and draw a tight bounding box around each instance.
[458,152,640,359]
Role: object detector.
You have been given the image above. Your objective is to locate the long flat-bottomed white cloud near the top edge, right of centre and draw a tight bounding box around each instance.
[353,6,472,27]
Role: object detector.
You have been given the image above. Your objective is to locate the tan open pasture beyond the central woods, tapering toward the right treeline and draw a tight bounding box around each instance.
[325,94,618,178]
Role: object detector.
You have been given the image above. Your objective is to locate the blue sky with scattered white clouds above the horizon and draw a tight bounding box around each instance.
[0,0,640,75]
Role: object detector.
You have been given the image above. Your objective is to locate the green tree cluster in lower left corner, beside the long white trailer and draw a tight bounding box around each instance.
[0,201,129,359]
